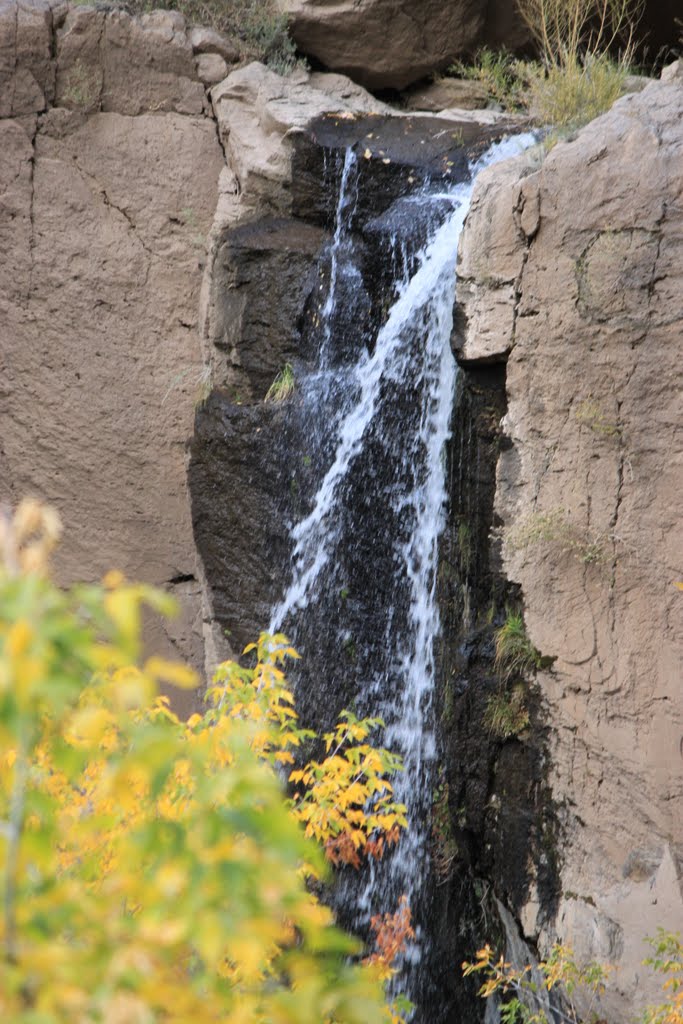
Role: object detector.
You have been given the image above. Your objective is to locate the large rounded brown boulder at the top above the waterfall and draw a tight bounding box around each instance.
[279,0,485,89]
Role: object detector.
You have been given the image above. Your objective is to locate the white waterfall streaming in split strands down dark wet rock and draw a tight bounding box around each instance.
[270,135,533,1020]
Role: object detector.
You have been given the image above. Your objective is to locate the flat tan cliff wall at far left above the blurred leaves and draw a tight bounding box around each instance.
[0,0,223,688]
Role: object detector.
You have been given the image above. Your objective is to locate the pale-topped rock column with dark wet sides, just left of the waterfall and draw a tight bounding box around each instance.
[189,63,511,662]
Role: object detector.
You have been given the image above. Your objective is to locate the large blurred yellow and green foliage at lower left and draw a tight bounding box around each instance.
[0,503,410,1024]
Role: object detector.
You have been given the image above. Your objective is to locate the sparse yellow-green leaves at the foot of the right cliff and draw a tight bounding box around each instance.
[463,930,683,1024]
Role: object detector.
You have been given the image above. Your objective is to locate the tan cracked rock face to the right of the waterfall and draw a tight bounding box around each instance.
[455,76,683,1021]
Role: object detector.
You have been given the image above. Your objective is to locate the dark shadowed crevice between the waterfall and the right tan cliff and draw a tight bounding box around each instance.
[437,362,560,1022]
